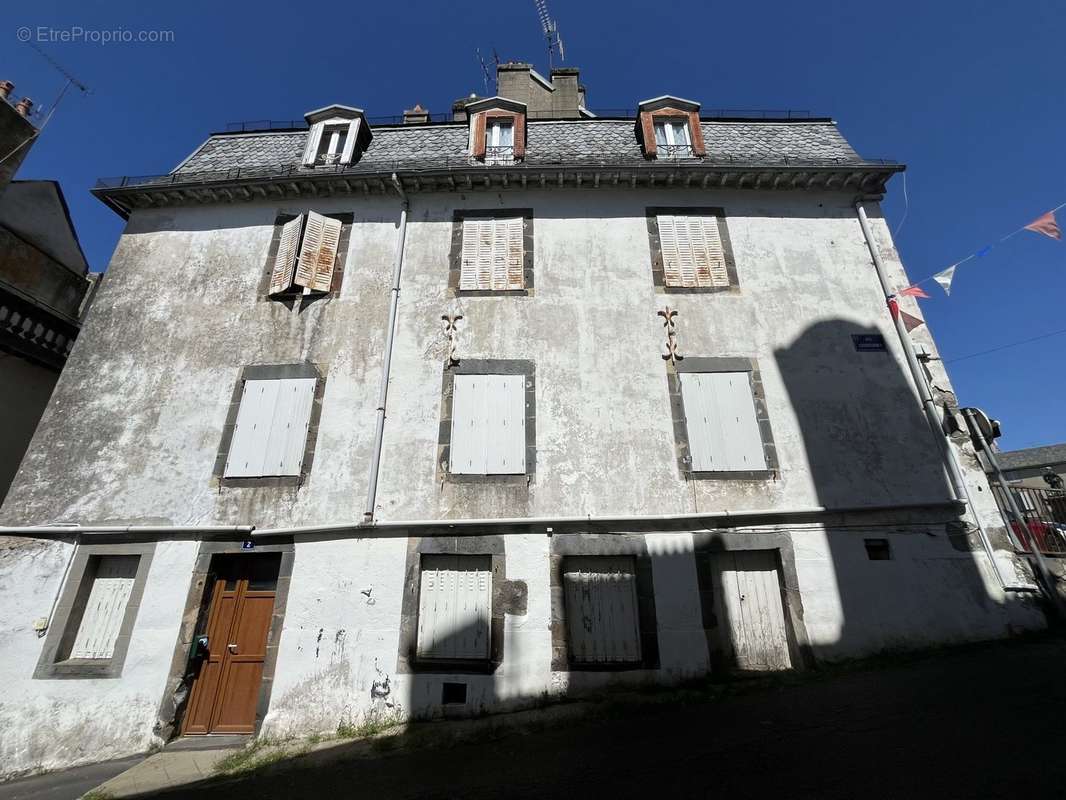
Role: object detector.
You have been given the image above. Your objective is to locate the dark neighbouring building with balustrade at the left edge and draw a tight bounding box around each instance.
[0,81,95,507]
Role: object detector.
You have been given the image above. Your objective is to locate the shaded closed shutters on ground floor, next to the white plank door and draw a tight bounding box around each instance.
[563,556,641,663]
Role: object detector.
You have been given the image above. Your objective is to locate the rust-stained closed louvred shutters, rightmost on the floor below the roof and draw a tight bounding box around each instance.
[658,214,729,288]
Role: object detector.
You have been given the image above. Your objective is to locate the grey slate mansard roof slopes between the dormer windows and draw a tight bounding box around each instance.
[172,119,866,174]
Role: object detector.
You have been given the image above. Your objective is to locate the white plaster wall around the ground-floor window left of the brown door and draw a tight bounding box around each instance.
[0,538,196,780]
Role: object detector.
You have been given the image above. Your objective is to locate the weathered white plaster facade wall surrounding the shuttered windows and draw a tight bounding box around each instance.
[0,189,1043,766]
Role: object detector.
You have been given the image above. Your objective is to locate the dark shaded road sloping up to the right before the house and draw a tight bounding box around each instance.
[8,639,1066,800]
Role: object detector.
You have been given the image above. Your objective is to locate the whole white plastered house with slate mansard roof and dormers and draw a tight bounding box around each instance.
[0,64,1045,785]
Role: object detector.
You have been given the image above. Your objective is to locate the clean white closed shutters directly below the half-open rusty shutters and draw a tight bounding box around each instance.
[225,378,317,478]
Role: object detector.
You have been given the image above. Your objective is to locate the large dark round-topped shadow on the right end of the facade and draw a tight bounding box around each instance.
[775,319,1002,659]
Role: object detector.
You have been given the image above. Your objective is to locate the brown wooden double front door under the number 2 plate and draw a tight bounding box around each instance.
[181,554,281,735]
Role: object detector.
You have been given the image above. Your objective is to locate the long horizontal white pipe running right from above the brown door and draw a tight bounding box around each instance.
[252,500,960,539]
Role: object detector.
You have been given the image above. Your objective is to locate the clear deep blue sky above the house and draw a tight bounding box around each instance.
[8,0,1066,448]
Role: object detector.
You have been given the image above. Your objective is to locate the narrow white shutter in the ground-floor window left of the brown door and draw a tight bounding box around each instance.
[69,556,141,658]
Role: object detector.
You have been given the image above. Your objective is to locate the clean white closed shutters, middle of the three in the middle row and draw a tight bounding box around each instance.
[449,374,526,475]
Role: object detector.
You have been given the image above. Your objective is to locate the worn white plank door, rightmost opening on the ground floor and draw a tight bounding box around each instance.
[714,550,792,671]
